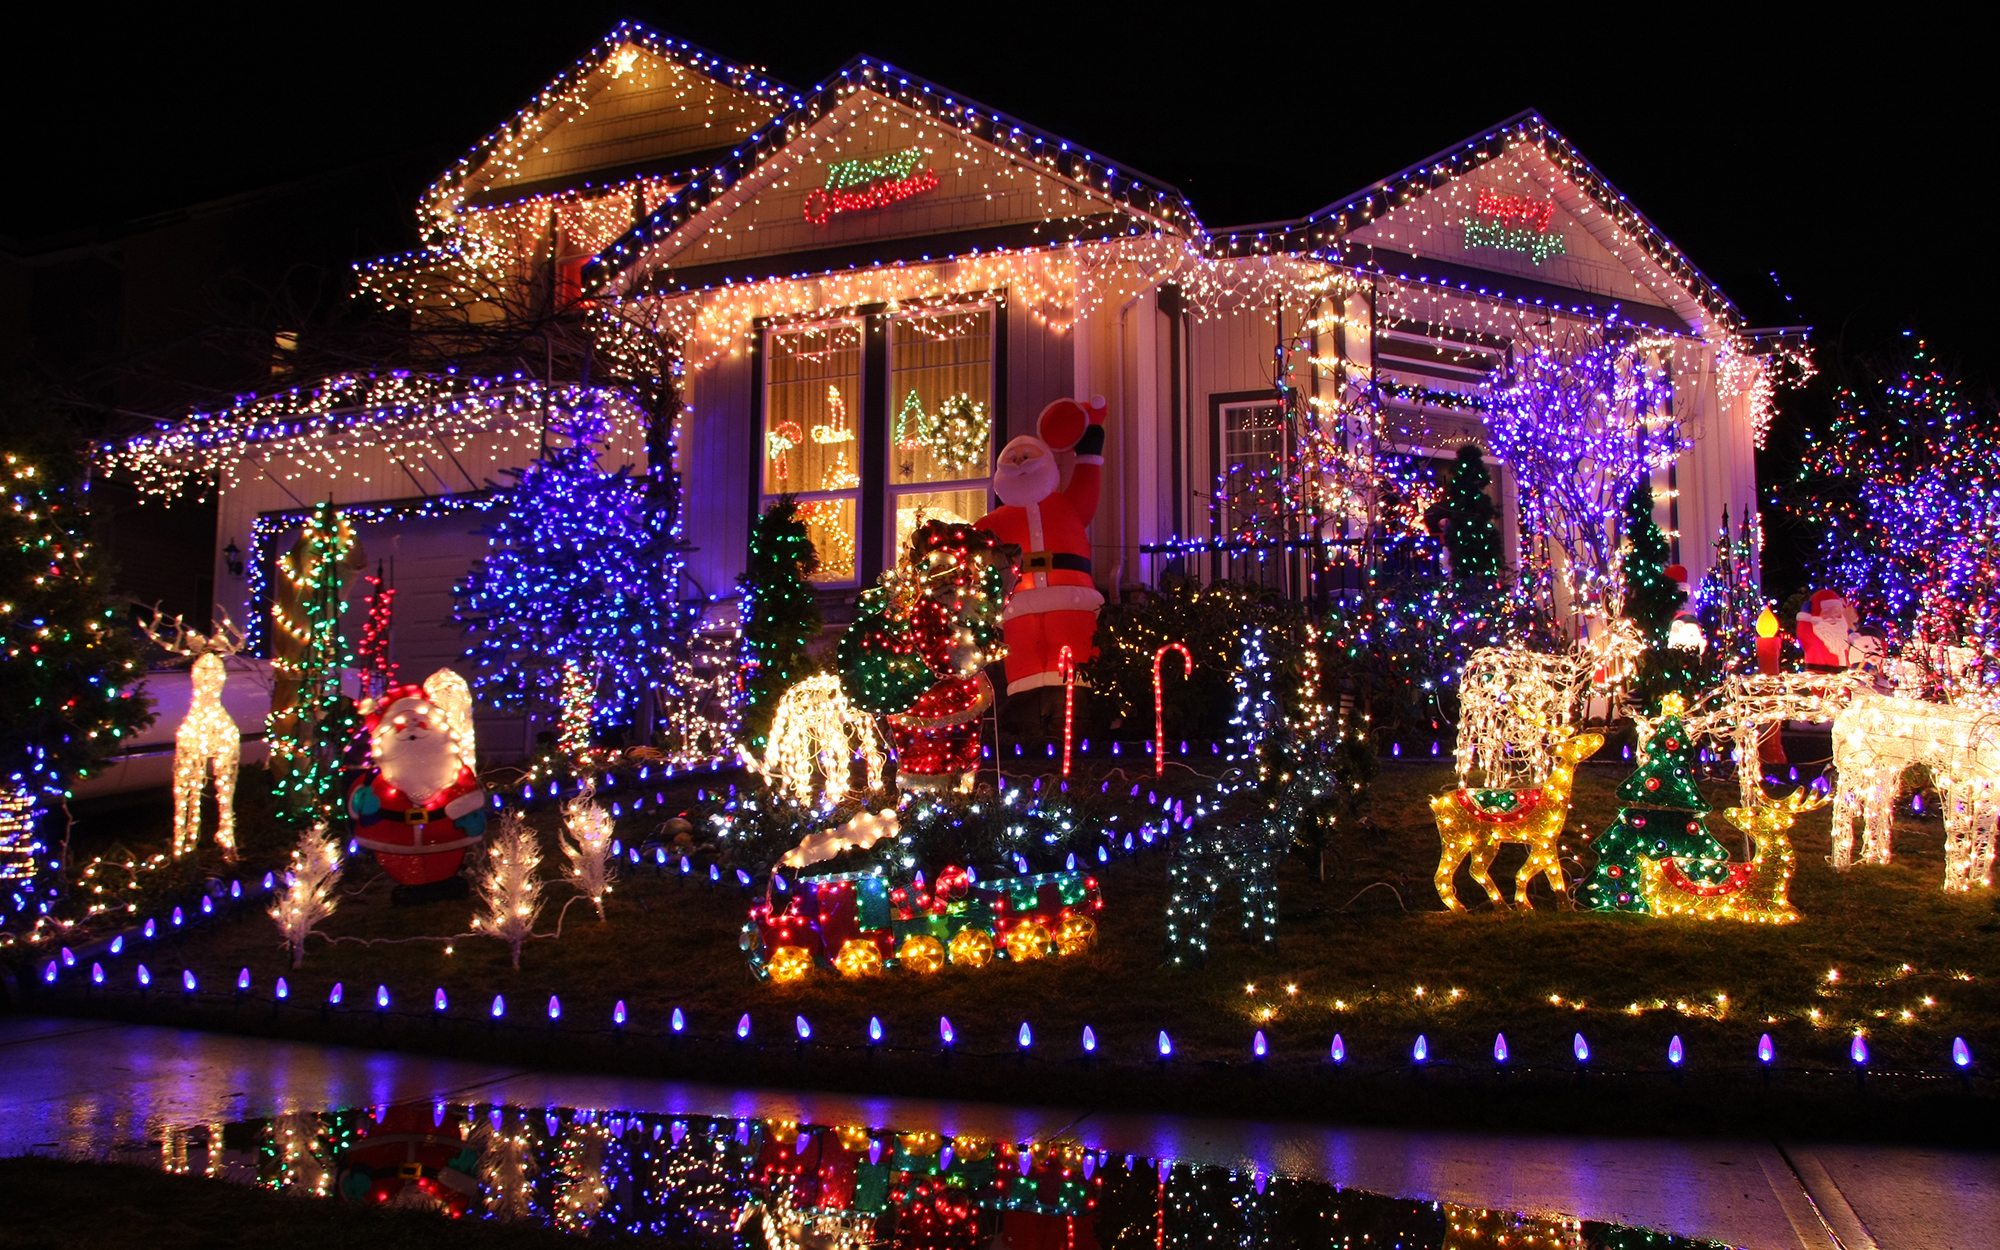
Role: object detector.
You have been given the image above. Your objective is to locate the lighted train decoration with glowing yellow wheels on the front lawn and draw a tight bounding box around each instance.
[742,868,1104,984]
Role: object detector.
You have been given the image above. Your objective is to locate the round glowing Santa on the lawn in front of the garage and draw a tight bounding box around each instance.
[348,668,486,886]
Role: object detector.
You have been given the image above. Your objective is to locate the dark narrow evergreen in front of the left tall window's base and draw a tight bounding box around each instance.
[736,496,824,758]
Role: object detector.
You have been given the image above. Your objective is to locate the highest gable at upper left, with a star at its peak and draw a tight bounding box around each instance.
[464,42,784,204]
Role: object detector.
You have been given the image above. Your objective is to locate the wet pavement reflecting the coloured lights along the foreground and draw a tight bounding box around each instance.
[0,1018,2000,1250]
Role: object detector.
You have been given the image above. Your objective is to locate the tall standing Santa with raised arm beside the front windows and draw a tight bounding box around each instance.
[974,396,1104,694]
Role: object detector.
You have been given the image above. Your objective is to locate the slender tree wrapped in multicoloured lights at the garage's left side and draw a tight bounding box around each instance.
[266,504,358,826]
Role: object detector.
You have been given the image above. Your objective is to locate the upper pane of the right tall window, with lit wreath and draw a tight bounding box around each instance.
[888,308,994,486]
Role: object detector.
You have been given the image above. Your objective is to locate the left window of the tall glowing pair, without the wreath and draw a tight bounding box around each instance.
[762,322,862,582]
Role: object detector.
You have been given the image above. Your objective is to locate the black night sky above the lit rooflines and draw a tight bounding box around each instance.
[0,2,2000,382]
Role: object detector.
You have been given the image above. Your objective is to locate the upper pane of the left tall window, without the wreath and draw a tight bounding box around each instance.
[764,324,862,494]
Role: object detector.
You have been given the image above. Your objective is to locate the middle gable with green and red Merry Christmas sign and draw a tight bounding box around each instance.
[624,90,1156,270]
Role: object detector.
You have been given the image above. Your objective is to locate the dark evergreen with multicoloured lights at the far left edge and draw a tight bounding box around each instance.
[0,450,152,928]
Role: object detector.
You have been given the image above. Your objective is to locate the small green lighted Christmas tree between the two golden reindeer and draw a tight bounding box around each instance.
[1582,694,1730,912]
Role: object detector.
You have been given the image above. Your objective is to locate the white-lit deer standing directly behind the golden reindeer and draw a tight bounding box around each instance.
[1456,620,1646,788]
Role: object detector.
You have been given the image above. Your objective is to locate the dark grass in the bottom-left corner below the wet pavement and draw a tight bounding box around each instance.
[0,1156,574,1250]
